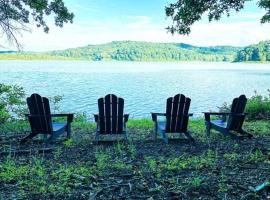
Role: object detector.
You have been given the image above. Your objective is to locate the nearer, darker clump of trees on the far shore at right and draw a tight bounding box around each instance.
[235,41,270,62]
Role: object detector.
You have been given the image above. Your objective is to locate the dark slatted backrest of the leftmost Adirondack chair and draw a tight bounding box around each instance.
[27,94,52,134]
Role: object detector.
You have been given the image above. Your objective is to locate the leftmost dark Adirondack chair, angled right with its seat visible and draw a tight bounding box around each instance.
[21,94,73,143]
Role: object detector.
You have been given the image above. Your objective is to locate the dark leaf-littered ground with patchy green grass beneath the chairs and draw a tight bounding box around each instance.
[0,120,270,200]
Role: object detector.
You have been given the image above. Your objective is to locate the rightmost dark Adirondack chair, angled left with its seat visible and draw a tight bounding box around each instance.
[204,95,252,139]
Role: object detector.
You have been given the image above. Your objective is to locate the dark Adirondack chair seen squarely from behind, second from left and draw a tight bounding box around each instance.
[94,94,129,142]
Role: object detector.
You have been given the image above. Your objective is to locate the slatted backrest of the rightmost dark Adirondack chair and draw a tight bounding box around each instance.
[227,95,247,130]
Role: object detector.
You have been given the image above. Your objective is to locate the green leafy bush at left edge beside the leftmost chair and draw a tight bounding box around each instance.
[0,83,25,124]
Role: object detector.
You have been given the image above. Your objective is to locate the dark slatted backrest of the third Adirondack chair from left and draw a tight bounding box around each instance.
[166,94,191,133]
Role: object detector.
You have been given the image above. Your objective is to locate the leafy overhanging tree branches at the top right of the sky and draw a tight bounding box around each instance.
[165,0,270,35]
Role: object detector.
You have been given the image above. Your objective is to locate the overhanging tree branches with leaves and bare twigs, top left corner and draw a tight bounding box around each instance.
[0,0,74,49]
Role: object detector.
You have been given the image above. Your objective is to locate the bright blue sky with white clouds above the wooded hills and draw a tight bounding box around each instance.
[0,0,270,51]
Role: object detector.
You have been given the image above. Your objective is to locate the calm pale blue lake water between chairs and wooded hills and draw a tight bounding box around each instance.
[0,61,270,118]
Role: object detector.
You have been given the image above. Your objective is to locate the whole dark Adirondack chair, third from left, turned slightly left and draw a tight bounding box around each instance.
[151,94,194,143]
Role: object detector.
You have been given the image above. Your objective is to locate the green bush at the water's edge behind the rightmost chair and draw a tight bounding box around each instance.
[219,90,270,120]
